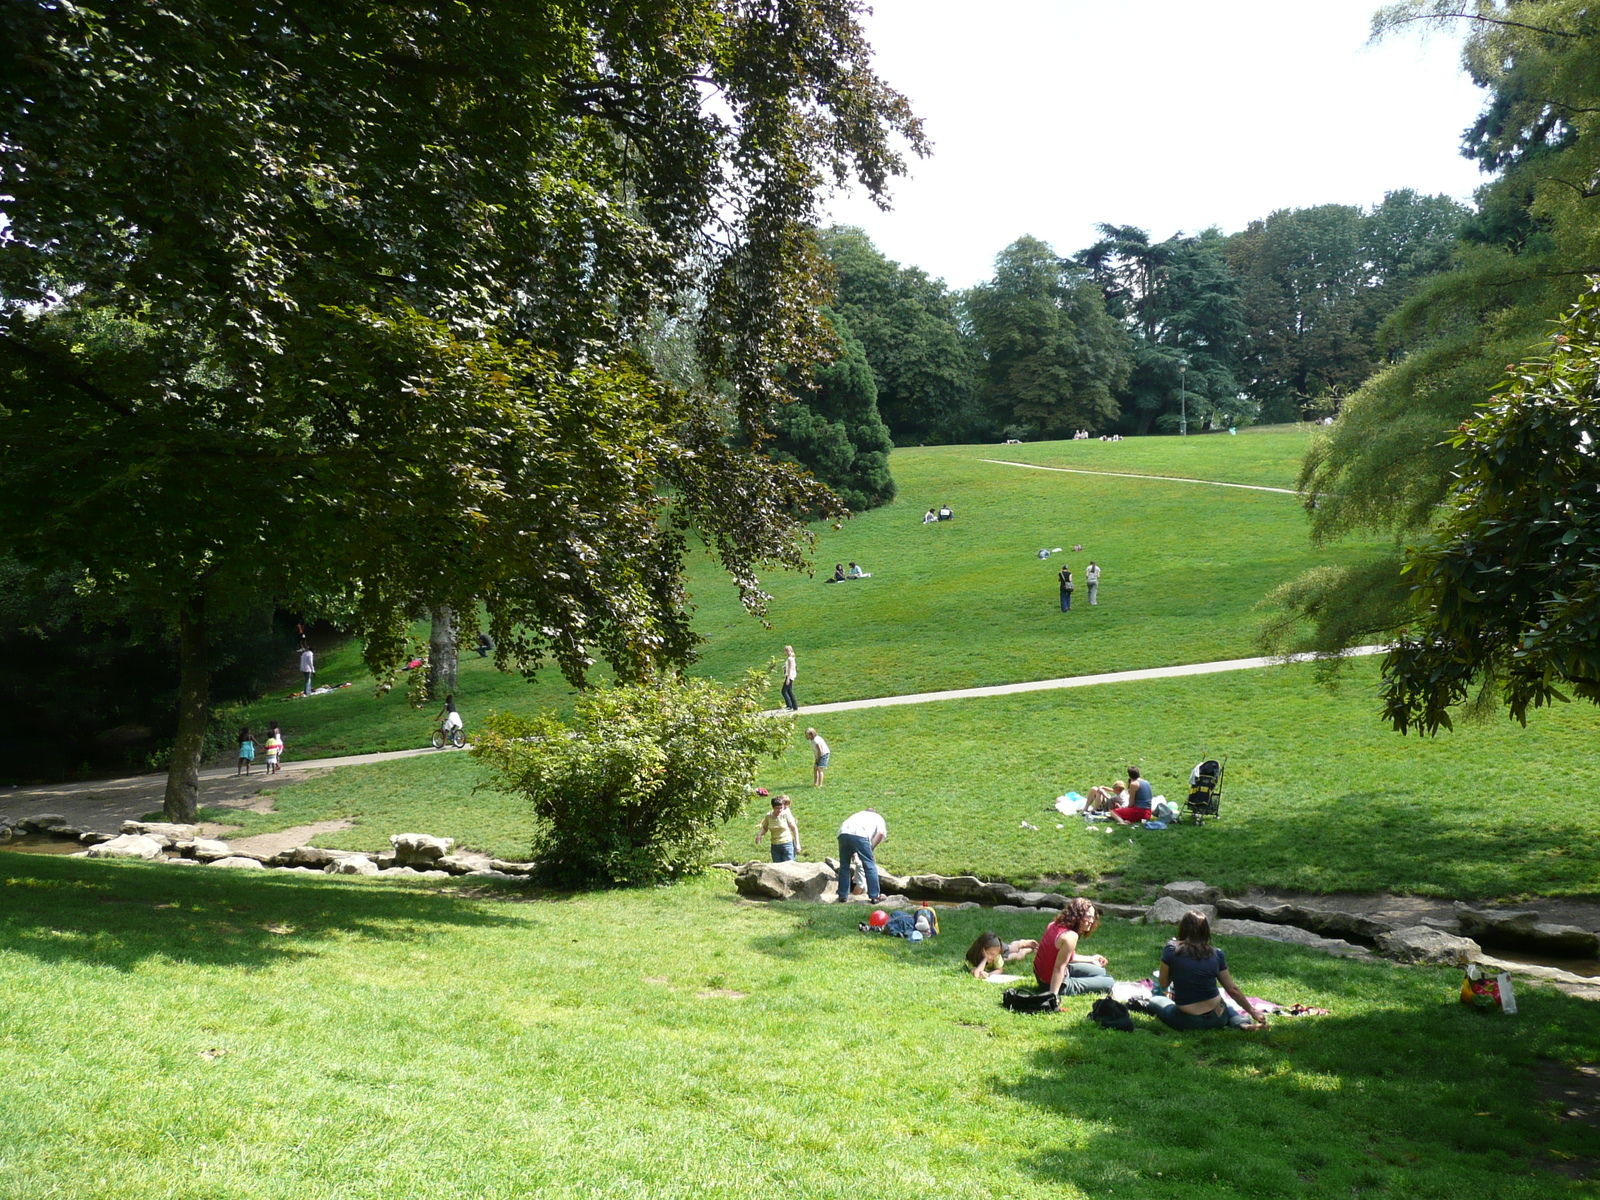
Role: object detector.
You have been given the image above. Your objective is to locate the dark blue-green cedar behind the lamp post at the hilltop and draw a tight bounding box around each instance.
[1074,224,1254,435]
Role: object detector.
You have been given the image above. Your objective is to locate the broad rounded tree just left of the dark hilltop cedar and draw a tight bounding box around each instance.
[966,237,1130,435]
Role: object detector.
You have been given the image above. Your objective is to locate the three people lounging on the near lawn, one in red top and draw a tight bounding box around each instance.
[966,896,1267,1029]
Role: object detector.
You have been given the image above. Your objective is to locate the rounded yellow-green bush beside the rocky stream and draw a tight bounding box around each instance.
[472,670,792,886]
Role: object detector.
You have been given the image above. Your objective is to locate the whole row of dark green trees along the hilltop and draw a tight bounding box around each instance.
[825,190,1472,448]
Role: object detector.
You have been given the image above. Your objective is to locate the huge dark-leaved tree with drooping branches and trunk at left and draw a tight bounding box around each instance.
[0,0,925,819]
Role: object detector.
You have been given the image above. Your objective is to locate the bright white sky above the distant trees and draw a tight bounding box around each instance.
[830,0,1483,288]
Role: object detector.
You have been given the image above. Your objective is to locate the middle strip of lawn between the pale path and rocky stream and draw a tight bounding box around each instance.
[218,659,1600,899]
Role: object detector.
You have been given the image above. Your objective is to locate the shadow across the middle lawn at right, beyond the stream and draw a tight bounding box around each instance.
[1125,792,1600,899]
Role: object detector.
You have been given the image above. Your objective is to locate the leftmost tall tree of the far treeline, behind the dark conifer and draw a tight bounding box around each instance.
[818,226,978,445]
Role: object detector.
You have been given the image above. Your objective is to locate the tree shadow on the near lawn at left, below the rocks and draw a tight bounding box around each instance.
[0,854,517,971]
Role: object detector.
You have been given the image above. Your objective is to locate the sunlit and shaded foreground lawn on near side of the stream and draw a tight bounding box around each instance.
[0,854,1600,1200]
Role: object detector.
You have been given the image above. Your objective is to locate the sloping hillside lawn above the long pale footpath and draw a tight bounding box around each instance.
[233,432,1371,758]
